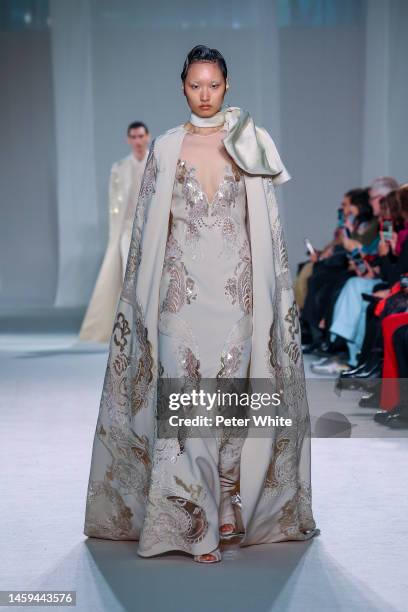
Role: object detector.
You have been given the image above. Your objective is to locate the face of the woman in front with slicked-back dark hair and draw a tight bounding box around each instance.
[184,61,226,117]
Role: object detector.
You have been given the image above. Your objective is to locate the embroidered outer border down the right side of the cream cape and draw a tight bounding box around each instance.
[263,178,316,541]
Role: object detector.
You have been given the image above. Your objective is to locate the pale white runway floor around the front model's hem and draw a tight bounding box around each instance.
[0,334,408,612]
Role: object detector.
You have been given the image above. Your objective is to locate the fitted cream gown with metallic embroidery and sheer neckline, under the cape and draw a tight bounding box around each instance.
[138,126,252,556]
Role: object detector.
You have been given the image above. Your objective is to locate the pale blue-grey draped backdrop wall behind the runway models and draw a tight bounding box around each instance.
[0,0,408,308]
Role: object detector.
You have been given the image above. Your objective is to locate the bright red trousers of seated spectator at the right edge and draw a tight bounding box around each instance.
[380,312,408,410]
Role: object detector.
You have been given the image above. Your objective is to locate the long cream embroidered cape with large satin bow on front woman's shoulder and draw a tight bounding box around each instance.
[84,109,318,546]
